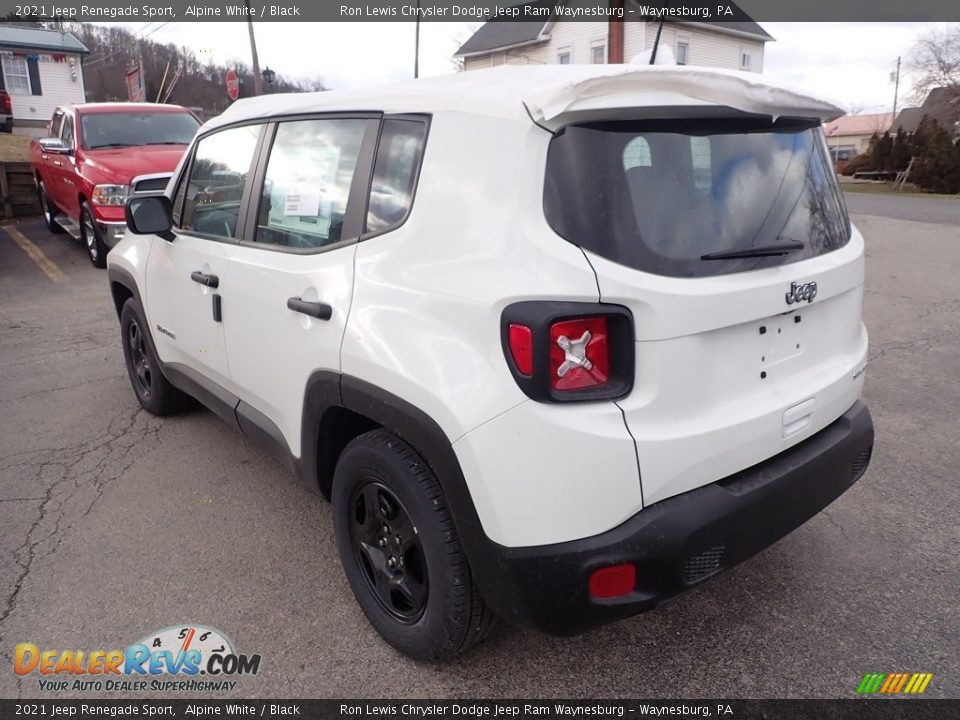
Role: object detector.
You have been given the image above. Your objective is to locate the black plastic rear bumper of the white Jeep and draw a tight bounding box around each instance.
[474,402,873,635]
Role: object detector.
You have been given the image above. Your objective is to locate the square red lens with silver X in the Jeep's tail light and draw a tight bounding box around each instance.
[550,317,610,392]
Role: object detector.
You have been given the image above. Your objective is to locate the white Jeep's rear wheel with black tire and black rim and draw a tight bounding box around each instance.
[332,430,493,660]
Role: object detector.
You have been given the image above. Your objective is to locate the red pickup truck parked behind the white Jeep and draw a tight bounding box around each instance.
[30,103,200,268]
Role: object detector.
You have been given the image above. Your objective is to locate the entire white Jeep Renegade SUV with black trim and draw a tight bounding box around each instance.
[109,66,873,659]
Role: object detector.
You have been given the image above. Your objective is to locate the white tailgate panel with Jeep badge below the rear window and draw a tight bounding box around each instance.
[588,229,867,505]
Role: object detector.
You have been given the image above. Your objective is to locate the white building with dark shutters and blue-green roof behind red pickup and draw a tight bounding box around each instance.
[0,25,89,135]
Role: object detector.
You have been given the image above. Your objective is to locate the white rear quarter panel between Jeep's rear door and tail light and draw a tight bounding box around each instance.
[341,114,597,442]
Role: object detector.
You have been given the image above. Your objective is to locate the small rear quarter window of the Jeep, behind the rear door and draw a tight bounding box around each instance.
[366,119,427,233]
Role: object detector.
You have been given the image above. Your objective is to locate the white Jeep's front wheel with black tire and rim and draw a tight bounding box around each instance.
[120,298,190,415]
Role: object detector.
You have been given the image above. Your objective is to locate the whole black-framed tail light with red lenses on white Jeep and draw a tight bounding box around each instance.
[501,301,634,403]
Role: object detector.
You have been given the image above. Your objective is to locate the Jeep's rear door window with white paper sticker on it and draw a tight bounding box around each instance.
[254,119,369,248]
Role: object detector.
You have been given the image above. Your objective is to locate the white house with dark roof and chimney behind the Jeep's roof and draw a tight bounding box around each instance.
[455,0,773,72]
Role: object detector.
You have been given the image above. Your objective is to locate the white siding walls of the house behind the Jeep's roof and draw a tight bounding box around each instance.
[464,20,764,72]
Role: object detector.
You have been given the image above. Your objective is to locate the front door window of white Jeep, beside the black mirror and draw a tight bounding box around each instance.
[175,125,263,238]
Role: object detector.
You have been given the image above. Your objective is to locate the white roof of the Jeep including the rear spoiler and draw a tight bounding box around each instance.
[203,64,844,130]
